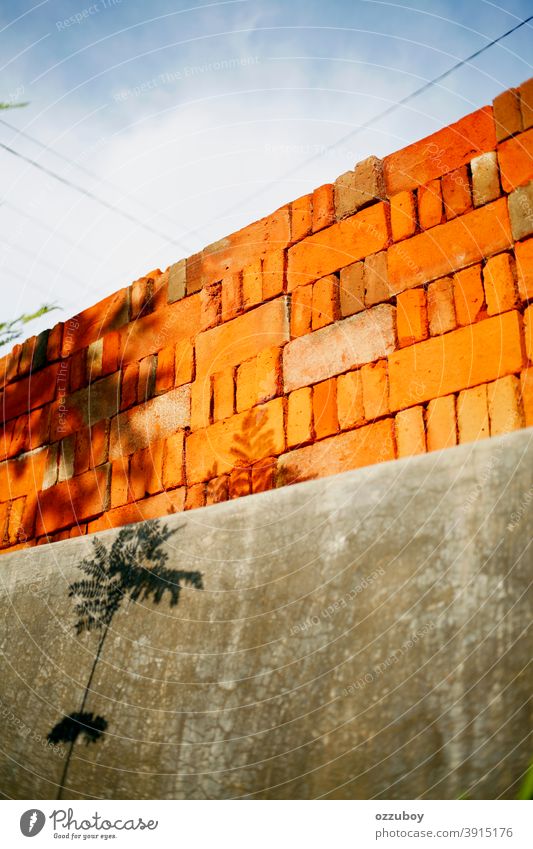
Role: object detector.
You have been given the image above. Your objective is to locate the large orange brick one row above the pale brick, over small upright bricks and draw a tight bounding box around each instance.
[287,203,389,292]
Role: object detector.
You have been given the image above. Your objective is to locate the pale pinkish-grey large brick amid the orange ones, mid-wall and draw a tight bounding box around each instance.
[283,304,396,392]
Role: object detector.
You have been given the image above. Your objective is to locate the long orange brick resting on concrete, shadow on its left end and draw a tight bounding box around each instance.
[278,419,395,483]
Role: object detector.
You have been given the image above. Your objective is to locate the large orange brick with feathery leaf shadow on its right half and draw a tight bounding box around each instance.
[186,398,285,485]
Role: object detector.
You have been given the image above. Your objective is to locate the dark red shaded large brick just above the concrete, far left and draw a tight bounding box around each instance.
[36,466,109,536]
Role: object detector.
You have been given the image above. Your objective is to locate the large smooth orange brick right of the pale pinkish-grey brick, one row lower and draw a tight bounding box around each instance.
[389,311,523,410]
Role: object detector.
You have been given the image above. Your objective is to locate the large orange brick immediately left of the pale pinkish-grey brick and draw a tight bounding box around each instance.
[196,298,289,377]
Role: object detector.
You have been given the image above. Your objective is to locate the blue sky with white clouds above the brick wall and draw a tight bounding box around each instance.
[0,0,533,338]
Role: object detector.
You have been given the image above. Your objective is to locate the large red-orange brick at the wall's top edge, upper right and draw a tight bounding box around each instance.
[384,106,496,196]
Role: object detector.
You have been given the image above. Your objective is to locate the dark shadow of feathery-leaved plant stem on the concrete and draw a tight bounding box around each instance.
[48,519,203,799]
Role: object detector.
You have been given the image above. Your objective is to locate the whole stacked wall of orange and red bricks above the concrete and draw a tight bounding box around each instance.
[0,80,533,550]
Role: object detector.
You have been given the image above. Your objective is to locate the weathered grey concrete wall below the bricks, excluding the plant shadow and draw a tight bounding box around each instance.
[0,430,533,799]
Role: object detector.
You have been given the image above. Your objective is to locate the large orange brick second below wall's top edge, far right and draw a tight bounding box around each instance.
[388,198,512,294]
